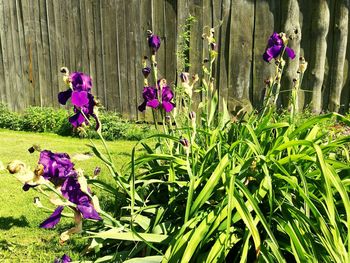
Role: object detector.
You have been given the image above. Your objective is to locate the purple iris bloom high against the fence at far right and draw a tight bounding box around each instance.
[263,32,295,62]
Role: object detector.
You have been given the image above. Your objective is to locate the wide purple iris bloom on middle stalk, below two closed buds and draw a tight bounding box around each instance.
[138,86,175,112]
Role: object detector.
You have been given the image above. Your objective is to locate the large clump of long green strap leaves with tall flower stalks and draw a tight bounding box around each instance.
[6,29,350,263]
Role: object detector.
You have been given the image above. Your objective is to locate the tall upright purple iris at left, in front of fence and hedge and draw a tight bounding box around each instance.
[58,72,99,130]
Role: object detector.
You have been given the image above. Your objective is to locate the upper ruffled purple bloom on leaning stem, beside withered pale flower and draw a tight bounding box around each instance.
[38,150,76,185]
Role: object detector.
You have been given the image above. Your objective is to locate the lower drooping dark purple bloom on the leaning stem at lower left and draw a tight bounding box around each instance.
[61,177,101,220]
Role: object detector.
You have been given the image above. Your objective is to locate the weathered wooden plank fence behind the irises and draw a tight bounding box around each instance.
[0,0,350,119]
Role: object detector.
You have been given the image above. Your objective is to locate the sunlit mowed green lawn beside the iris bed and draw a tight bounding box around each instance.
[0,129,135,262]
